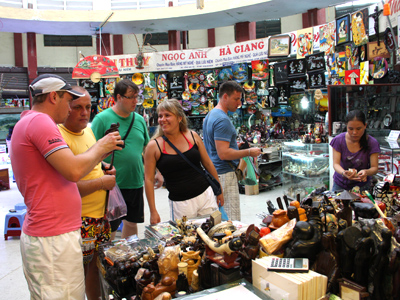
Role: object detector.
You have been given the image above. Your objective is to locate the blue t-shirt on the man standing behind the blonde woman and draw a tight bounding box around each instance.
[203,108,239,174]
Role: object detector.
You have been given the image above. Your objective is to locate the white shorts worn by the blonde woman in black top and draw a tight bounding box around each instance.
[169,186,218,220]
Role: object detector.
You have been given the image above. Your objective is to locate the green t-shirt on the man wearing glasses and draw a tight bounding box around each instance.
[91,108,150,189]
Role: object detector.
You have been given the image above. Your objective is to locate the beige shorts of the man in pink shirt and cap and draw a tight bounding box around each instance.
[21,229,85,300]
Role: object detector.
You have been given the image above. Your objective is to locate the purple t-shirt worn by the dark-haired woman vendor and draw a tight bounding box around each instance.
[330,132,381,190]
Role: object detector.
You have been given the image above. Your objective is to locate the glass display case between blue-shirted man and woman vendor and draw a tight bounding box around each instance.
[282,142,329,199]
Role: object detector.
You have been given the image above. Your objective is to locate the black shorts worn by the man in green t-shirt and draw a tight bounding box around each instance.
[110,187,144,232]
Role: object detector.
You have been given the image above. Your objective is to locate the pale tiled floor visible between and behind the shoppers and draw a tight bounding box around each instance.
[0,171,282,300]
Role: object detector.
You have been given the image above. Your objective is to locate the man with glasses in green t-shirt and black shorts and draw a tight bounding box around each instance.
[91,79,150,239]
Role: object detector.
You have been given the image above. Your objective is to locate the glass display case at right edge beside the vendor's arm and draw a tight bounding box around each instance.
[376,137,400,179]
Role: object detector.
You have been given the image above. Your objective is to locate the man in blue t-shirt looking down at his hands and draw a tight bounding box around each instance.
[203,81,261,221]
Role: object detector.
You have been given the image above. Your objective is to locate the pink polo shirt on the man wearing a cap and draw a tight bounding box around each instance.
[11,111,82,237]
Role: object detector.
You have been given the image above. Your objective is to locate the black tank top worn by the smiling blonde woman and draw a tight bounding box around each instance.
[155,134,209,201]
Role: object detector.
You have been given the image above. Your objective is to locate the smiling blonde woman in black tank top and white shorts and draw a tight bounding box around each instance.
[144,99,224,224]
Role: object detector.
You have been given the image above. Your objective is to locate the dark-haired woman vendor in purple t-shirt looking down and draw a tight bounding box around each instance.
[330,110,380,191]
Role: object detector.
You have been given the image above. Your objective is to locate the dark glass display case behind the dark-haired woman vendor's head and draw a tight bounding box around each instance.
[328,84,400,137]
